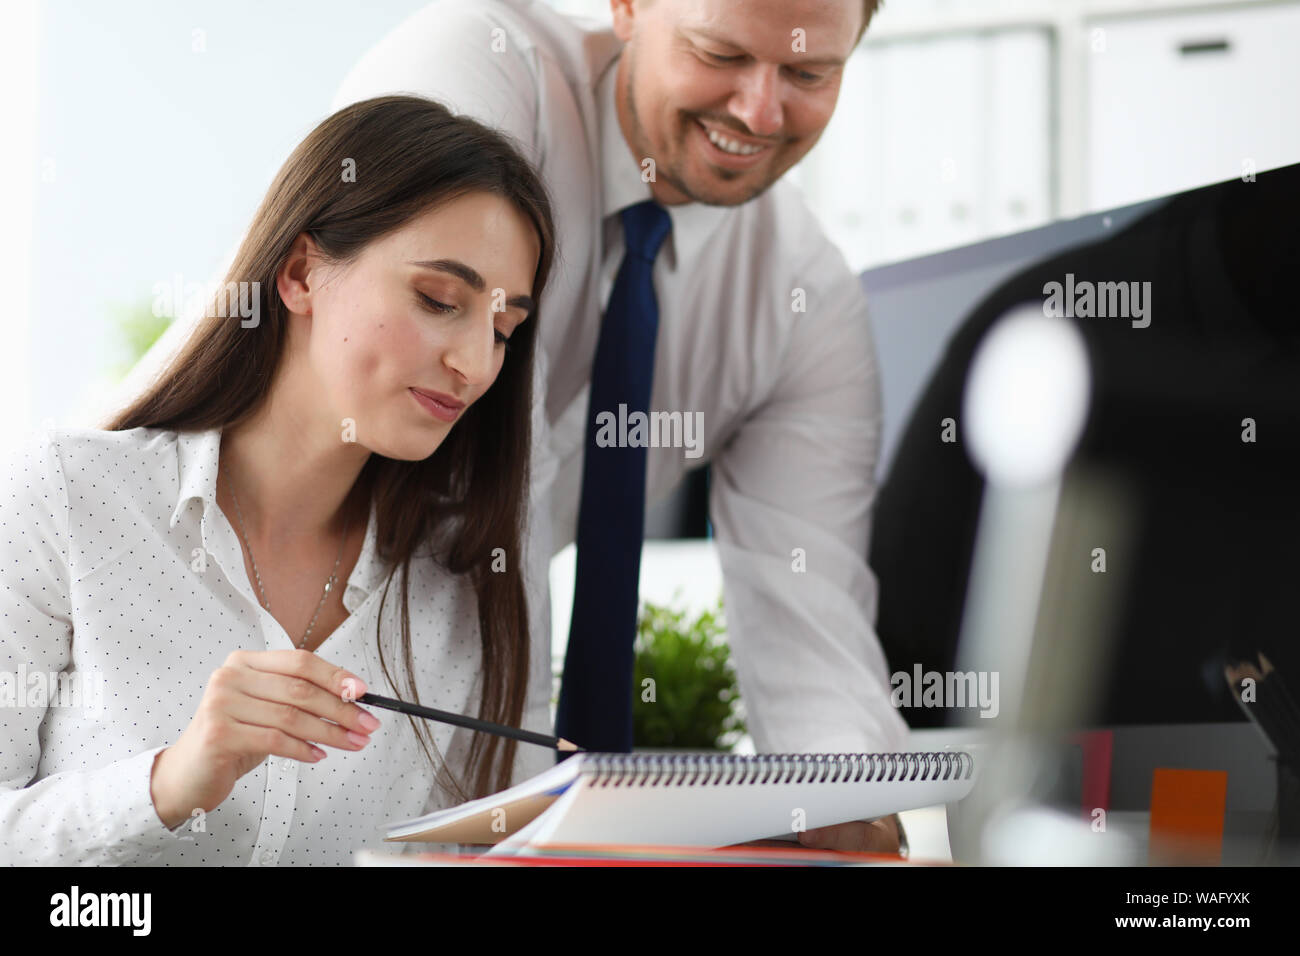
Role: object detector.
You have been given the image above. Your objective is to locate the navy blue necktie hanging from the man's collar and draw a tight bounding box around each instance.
[555,200,670,761]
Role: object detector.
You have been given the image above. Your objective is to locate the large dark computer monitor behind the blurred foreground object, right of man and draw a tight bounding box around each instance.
[863,165,1300,727]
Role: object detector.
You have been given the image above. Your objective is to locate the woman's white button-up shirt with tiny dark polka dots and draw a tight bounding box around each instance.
[0,428,554,866]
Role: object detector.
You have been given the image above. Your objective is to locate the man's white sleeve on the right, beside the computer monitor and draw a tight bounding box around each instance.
[710,257,907,753]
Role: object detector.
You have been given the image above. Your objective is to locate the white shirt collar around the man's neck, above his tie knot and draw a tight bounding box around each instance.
[595,53,735,268]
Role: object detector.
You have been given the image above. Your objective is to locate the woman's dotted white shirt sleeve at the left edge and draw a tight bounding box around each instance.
[0,431,187,866]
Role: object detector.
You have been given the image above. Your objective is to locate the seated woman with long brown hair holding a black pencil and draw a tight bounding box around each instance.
[0,96,554,865]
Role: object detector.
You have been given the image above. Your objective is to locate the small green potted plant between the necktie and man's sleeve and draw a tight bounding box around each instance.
[632,597,746,752]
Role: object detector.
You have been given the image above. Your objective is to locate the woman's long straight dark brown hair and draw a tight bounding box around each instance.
[103,96,555,800]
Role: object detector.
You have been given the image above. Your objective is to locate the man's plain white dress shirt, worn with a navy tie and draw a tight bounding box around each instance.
[332,0,907,753]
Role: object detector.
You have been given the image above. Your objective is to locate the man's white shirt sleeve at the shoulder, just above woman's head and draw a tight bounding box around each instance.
[330,0,540,164]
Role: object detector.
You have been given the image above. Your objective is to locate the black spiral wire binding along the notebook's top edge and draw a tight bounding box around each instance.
[582,750,975,787]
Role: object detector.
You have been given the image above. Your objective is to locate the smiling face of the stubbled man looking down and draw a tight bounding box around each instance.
[611,0,865,206]
